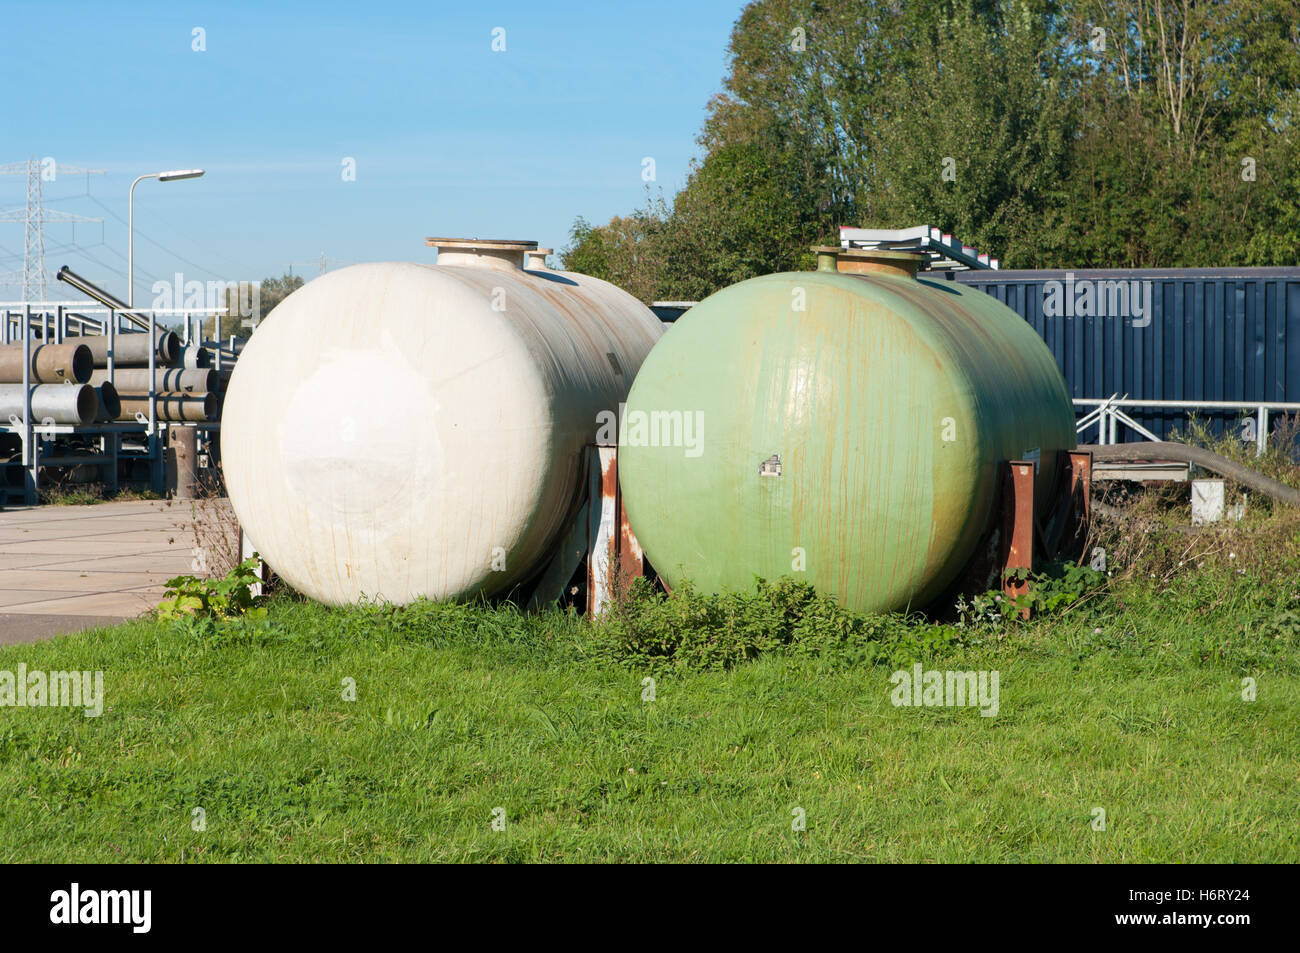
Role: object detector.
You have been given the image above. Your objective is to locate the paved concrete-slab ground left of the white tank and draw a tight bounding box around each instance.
[0,501,233,644]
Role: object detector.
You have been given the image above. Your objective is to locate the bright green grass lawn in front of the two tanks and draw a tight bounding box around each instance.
[0,556,1300,862]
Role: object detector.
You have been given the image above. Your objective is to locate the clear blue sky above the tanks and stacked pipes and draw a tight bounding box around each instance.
[0,0,744,300]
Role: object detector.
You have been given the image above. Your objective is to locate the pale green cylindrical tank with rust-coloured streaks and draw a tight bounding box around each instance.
[619,248,1075,612]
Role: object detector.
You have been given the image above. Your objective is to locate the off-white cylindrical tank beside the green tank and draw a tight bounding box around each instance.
[221,239,663,605]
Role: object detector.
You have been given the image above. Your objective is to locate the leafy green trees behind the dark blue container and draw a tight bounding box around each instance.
[563,0,1300,302]
